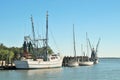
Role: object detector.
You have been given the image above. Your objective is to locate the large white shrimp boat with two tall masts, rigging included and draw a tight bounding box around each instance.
[14,12,63,69]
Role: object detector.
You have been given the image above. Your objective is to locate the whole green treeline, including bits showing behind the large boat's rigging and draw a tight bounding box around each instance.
[0,43,54,63]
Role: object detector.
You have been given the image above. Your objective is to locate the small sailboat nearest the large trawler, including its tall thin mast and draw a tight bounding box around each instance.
[68,24,79,67]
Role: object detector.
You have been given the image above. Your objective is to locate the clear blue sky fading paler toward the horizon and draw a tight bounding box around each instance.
[0,0,120,57]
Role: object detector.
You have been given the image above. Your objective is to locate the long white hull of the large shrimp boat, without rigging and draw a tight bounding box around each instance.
[14,59,63,69]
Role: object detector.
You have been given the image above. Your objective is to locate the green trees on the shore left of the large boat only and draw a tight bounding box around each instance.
[0,43,23,64]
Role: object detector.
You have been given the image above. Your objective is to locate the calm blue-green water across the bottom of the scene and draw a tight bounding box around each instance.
[0,59,120,80]
